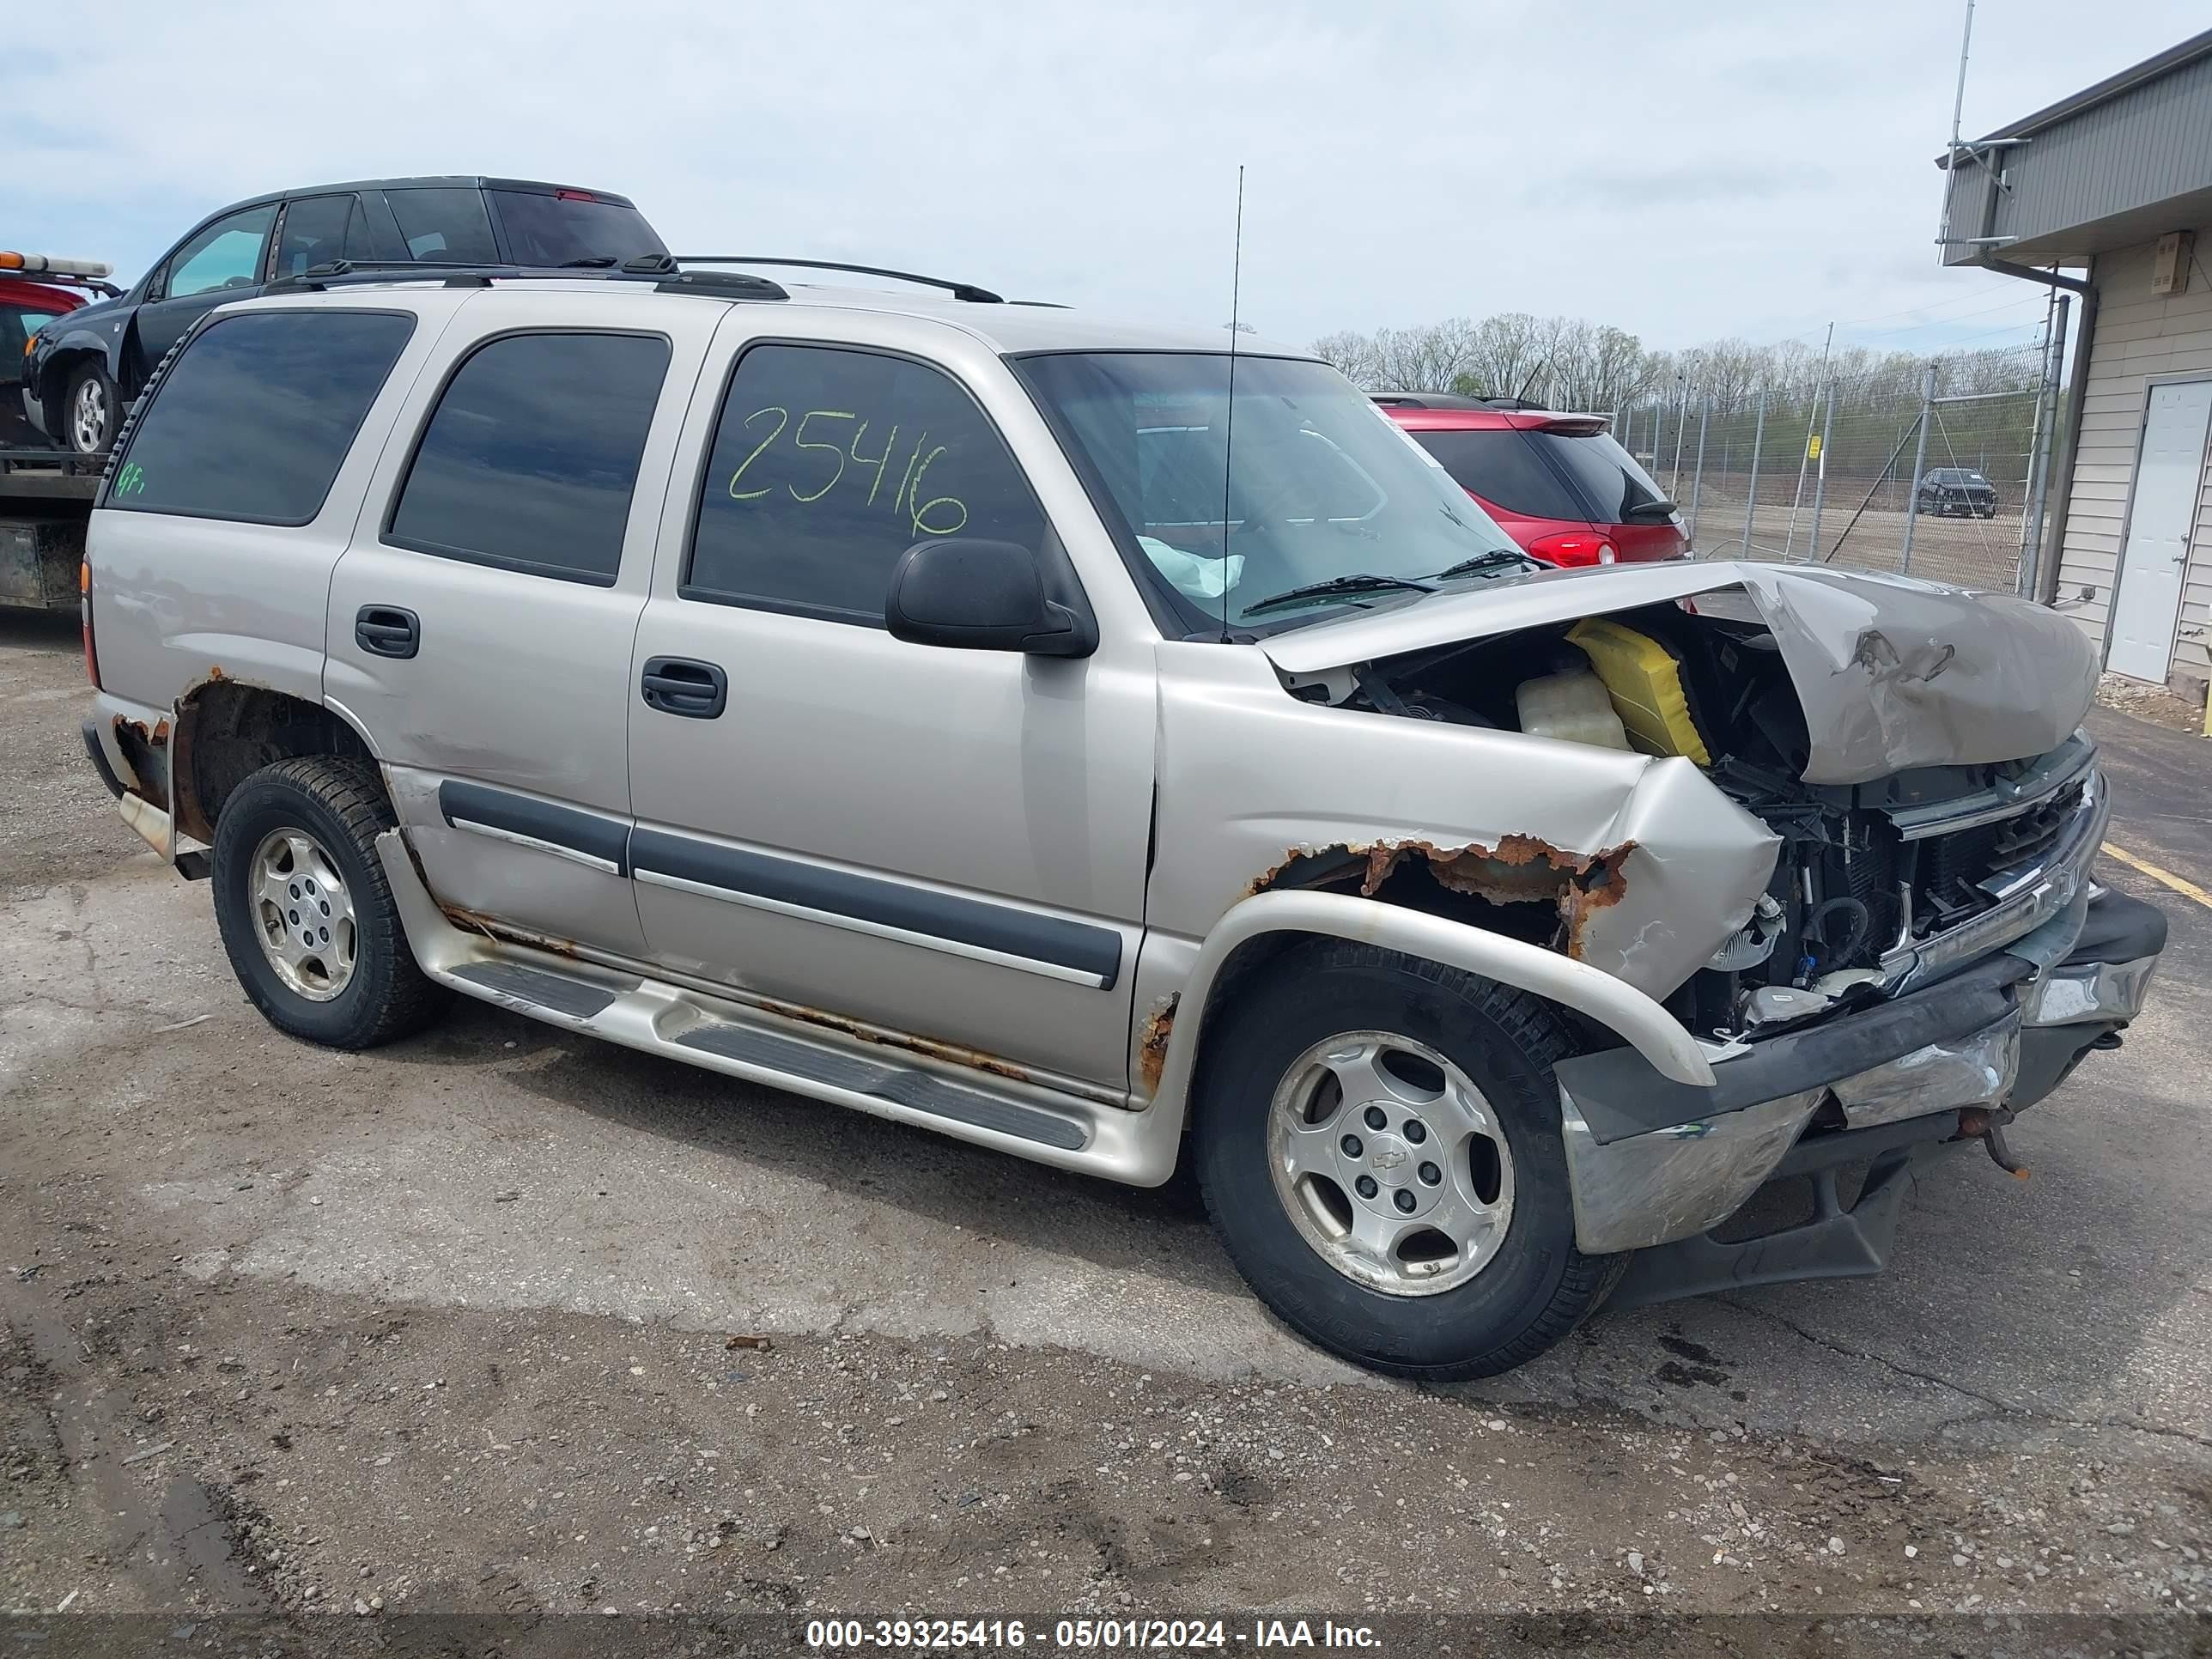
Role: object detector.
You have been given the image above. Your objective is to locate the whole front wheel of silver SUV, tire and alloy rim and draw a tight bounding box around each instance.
[1192,940,1628,1382]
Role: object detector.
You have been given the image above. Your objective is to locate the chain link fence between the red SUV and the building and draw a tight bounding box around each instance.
[1613,345,2057,591]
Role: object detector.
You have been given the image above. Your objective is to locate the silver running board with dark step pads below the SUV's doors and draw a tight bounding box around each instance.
[376,830,1182,1186]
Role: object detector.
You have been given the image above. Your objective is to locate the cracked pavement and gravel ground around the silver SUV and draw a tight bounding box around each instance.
[0,619,2212,1652]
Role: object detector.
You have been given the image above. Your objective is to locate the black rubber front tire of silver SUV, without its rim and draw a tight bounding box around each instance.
[1194,957,1589,1378]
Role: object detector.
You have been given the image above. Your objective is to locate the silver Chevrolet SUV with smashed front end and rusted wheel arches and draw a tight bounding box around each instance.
[84,261,2166,1380]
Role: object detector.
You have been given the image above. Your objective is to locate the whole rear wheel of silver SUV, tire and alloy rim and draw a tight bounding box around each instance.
[212,754,447,1048]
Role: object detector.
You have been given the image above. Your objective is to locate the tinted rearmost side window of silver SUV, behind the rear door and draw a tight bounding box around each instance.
[106,310,414,525]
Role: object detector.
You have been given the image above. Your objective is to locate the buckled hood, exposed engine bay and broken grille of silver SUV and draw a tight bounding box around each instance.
[1279,566,2104,1042]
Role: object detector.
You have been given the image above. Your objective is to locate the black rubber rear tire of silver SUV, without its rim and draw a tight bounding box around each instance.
[210,772,411,1048]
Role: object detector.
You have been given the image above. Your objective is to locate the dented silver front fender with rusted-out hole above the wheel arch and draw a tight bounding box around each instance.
[1146,644,1781,998]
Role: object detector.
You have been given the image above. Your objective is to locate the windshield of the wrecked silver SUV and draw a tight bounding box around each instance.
[1015,352,1517,633]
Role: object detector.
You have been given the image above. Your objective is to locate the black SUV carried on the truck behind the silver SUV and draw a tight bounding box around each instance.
[22,177,668,456]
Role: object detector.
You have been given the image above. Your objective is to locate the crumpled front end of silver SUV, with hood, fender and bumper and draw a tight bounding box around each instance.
[1170,564,2163,1301]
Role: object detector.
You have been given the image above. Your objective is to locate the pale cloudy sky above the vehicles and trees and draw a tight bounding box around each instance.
[0,0,2203,358]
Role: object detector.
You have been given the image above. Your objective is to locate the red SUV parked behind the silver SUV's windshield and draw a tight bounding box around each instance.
[1374,392,1690,564]
